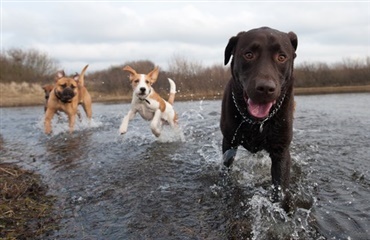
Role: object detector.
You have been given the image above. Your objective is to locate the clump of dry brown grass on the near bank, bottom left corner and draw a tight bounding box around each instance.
[0,164,57,239]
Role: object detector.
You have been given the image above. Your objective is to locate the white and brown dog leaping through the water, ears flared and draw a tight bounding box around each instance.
[119,66,177,137]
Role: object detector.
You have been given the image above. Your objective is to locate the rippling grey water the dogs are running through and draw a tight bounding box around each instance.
[0,94,370,240]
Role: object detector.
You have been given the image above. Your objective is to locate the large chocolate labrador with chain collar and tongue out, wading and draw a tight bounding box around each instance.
[220,27,298,201]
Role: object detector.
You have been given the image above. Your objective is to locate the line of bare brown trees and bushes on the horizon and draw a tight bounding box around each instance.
[0,49,370,96]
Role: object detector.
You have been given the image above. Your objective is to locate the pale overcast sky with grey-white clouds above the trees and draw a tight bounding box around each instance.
[1,0,370,72]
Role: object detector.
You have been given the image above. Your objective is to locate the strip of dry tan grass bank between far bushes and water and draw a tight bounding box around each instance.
[0,83,370,107]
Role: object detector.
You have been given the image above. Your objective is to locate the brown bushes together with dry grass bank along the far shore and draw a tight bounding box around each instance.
[0,49,370,106]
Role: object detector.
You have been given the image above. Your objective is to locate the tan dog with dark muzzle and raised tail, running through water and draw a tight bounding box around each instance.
[44,65,92,134]
